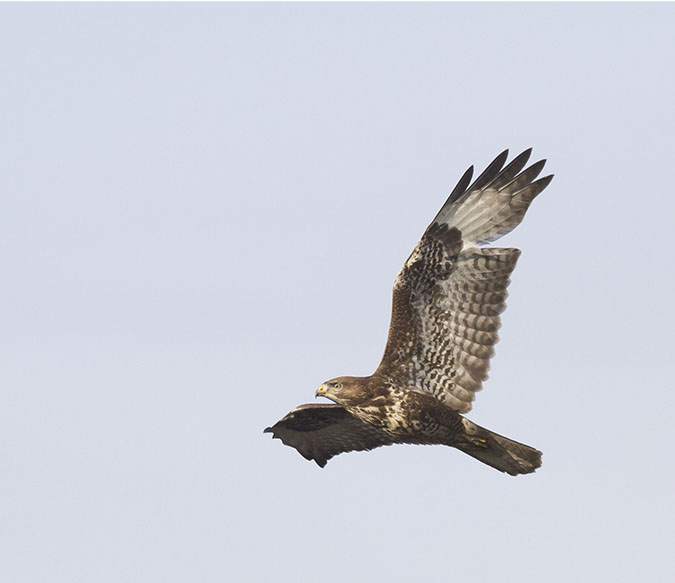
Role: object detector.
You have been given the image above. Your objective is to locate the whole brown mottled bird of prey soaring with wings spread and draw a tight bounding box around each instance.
[265,149,553,476]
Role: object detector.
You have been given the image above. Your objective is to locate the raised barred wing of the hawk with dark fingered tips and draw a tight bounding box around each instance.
[375,150,553,413]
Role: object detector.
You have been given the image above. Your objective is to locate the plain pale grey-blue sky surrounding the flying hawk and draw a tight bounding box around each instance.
[0,4,675,583]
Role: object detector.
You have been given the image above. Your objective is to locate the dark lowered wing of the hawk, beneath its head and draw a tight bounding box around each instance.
[265,404,394,467]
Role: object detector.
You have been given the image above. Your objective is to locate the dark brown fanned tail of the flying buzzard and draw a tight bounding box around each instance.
[454,418,541,476]
